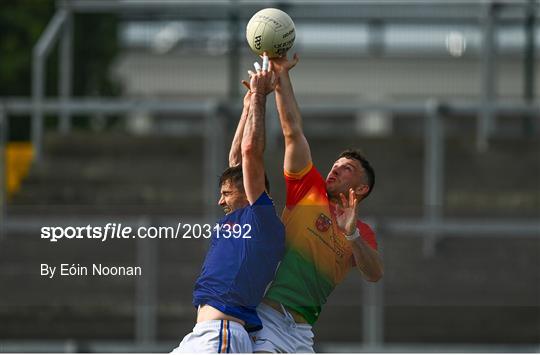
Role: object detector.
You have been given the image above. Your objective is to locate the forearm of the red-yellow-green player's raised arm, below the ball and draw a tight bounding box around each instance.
[276,72,302,139]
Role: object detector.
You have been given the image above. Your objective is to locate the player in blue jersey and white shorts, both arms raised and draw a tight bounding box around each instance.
[174,58,285,353]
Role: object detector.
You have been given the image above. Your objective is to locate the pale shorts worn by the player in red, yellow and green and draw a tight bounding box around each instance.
[250,303,314,353]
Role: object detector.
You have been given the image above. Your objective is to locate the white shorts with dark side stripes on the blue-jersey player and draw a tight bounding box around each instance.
[172,320,253,353]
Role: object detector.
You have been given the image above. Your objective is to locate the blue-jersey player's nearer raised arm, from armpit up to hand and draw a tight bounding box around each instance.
[242,57,275,204]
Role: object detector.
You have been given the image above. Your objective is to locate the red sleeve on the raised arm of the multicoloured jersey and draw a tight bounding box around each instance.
[284,163,326,209]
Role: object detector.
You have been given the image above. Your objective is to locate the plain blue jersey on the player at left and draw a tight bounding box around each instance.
[193,192,285,331]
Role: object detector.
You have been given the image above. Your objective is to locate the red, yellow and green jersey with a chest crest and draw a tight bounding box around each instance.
[266,163,377,324]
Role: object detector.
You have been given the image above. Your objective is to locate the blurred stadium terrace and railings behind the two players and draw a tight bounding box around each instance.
[0,0,540,352]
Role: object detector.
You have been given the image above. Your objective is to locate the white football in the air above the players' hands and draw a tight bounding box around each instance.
[246,8,296,58]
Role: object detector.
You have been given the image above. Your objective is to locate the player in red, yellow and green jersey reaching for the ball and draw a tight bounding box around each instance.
[252,55,383,353]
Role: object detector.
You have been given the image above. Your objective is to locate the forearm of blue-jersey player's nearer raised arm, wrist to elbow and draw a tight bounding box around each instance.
[241,94,266,159]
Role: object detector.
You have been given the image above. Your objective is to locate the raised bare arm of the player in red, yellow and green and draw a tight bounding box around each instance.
[270,54,311,173]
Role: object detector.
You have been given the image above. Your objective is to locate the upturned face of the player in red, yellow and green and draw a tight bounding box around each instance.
[326,158,367,197]
